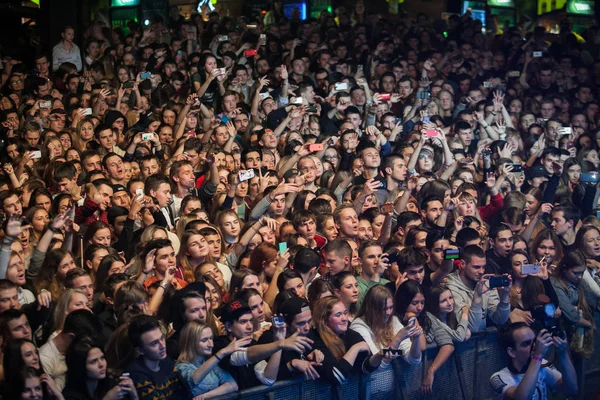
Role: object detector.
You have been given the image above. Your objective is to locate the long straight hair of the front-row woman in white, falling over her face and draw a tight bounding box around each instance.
[356,285,394,349]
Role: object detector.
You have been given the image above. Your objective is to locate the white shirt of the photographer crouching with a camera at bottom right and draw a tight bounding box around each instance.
[490,360,562,400]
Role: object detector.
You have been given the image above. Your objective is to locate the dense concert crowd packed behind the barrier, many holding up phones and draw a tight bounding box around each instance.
[0,1,600,400]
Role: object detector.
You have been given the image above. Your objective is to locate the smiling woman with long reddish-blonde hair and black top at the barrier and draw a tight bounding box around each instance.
[313,296,383,384]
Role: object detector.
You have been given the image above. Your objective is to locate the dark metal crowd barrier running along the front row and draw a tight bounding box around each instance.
[212,313,600,400]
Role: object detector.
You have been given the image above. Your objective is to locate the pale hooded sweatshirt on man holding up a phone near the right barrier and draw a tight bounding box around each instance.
[447,271,510,333]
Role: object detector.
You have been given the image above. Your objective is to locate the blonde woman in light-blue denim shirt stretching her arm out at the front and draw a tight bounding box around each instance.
[175,321,252,398]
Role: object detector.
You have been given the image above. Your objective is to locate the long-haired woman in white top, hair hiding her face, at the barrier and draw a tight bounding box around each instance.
[350,285,424,368]
